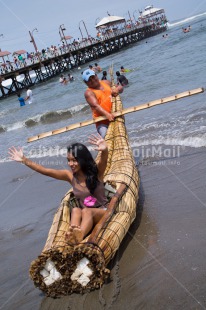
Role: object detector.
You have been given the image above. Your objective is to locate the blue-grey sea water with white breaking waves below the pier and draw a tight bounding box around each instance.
[0,13,206,161]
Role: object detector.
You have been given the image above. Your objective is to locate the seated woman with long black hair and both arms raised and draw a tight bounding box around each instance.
[9,135,108,244]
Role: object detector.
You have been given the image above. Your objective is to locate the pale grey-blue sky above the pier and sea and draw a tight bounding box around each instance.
[0,0,206,52]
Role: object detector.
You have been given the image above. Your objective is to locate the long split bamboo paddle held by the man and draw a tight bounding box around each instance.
[27,88,204,142]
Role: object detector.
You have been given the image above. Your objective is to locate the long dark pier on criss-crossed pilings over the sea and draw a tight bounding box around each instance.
[0,23,167,99]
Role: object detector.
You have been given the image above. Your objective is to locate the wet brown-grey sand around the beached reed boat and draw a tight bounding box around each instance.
[0,148,206,310]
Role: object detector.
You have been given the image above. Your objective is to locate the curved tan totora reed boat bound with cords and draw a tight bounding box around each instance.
[30,84,139,297]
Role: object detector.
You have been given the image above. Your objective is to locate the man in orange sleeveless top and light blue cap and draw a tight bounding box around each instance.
[82,69,123,138]
